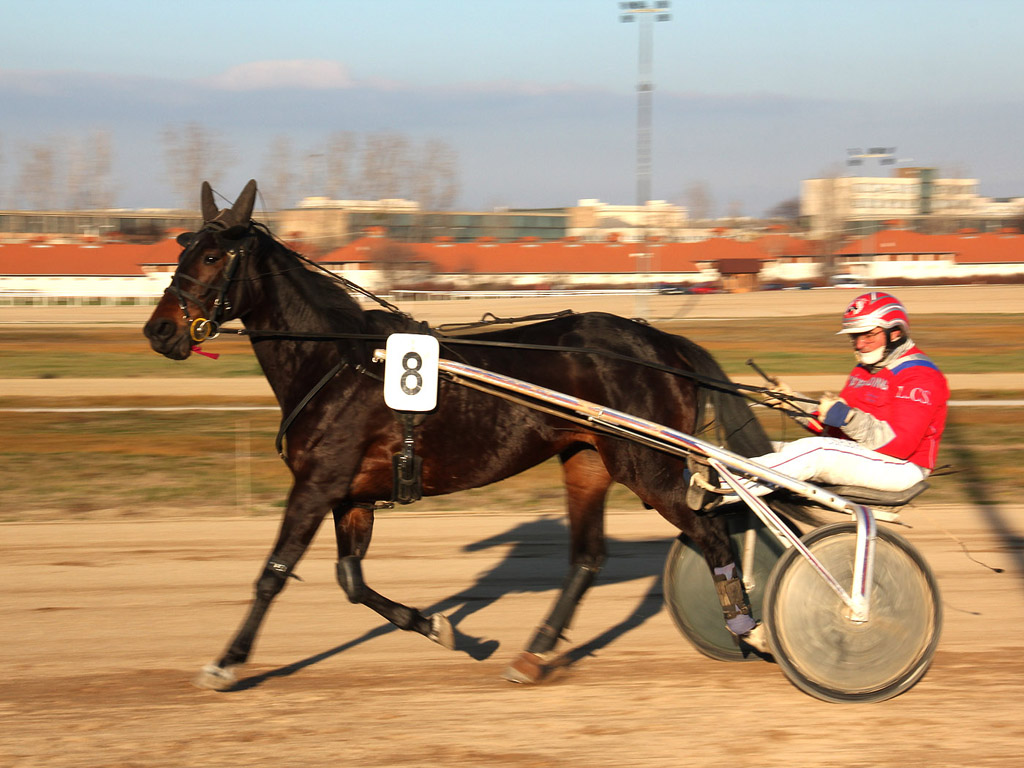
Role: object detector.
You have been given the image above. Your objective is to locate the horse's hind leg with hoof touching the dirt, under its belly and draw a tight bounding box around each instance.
[505,447,611,683]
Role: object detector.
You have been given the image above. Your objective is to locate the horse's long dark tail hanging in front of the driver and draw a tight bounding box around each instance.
[677,337,821,525]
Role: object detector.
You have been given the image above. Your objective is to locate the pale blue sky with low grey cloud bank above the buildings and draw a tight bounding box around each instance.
[0,0,1024,215]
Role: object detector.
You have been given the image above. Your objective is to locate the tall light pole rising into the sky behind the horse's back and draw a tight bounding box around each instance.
[618,0,672,317]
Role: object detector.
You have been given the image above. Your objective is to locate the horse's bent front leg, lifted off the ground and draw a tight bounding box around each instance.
[334,503,455,650]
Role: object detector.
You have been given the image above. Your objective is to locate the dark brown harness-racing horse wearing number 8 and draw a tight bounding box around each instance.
[144,181,769,689]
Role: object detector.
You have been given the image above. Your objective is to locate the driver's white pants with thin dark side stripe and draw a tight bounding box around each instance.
[751,437,928,490]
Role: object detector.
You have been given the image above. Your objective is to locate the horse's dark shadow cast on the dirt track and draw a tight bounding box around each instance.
[231,516,672,690]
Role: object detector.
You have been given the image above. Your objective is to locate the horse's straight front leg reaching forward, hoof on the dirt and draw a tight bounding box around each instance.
[193,483,329,690]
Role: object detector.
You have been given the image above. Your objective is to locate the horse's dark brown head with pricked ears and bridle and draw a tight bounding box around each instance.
[142,180,258,360]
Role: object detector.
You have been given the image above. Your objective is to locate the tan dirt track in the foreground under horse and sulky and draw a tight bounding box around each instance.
[6,507,1024,768]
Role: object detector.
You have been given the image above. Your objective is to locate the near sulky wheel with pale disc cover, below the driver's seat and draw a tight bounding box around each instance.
[762,522,942,701]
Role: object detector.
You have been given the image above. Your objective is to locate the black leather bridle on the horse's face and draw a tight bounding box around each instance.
[167,221,258,343]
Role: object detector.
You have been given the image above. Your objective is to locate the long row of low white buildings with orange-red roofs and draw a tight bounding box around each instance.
[0,227,1024,304]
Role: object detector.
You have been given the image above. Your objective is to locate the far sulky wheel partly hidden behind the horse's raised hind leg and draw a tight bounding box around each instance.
[662,513,784,662]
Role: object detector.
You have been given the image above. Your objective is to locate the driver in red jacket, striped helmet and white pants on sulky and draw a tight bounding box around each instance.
[720,291,949,495]
